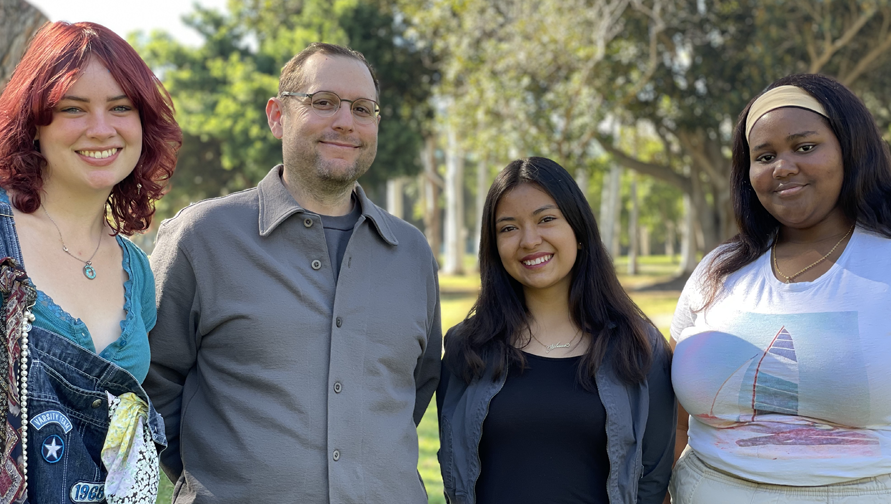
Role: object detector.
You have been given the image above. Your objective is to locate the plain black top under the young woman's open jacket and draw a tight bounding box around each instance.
[476,354,609,504]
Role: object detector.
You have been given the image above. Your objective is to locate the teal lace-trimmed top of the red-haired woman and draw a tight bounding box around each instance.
[0,188,157,383]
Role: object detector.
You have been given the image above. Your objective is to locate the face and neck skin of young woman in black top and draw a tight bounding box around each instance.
[495,184,590,357]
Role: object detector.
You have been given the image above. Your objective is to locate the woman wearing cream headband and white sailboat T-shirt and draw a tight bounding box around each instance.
[670,75,891,504]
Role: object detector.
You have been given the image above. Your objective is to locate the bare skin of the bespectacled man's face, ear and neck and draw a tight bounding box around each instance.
[266,53,380,216]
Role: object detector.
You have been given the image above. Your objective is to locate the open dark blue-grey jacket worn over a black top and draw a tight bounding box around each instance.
[436,327,677,504]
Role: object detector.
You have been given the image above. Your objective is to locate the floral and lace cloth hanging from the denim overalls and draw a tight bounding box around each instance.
[102,392,159,504]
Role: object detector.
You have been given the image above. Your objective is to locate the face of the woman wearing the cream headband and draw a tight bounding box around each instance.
[749,107,844,229]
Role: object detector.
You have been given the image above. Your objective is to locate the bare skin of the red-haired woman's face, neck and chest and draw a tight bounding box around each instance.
[13,59,142,353]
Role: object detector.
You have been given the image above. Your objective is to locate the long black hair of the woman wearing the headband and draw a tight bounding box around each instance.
[702,74,891,308]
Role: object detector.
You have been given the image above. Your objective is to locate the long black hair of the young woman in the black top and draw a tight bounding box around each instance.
[445,157,664,390]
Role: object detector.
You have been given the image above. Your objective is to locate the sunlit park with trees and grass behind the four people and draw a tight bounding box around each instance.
[0,0,891,503]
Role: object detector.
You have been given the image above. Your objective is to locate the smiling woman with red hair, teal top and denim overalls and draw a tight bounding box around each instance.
[0,22,182,503]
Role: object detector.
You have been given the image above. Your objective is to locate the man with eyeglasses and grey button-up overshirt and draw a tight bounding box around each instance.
[145,43,442,504]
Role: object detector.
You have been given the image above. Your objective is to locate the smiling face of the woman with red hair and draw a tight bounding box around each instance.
[36,58,142,196]
